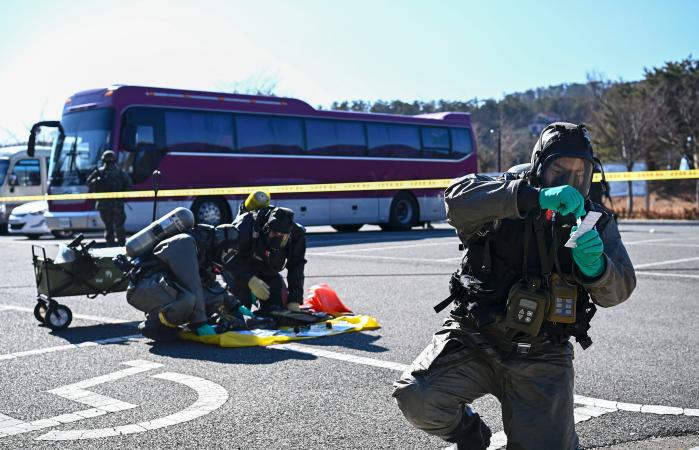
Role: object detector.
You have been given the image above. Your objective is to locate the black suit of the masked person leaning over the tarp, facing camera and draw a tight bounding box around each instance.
[226,209,306,313]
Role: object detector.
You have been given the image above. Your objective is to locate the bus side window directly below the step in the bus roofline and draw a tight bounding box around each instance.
[306,120,366,156]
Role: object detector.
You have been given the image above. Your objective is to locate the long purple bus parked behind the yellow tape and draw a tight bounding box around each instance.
[30,86,477,231]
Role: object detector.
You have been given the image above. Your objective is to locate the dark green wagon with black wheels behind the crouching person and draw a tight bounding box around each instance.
[32,234,129,330]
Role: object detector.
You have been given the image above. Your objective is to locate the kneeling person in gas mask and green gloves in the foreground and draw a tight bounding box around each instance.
[393,123,636,450]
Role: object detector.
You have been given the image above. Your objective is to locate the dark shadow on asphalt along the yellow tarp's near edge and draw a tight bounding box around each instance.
[149,341,318,365]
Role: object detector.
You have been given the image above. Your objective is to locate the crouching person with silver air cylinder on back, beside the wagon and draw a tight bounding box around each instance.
[126,208,251,340]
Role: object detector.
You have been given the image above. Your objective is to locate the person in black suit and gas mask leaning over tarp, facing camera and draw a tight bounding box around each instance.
[226,206,306,315]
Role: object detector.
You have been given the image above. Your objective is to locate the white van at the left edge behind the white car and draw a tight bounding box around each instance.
[0,145,51,231]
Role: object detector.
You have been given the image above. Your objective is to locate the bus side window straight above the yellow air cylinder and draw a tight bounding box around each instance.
[235,114,304,155]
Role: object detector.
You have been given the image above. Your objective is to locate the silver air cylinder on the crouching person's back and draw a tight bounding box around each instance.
[126,207,194,258]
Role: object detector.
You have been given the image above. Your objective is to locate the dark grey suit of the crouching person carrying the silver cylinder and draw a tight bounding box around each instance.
[126,225,238,328]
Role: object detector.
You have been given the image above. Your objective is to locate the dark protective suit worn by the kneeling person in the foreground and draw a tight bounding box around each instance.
[393,174,636,450]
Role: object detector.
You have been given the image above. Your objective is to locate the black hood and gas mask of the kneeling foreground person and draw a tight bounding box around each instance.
[530,122,595,197]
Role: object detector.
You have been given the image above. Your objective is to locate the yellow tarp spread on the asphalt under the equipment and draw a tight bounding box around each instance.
[180,315,381,347]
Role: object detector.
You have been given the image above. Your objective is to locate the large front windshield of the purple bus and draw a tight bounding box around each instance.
[51,108,114,186]
